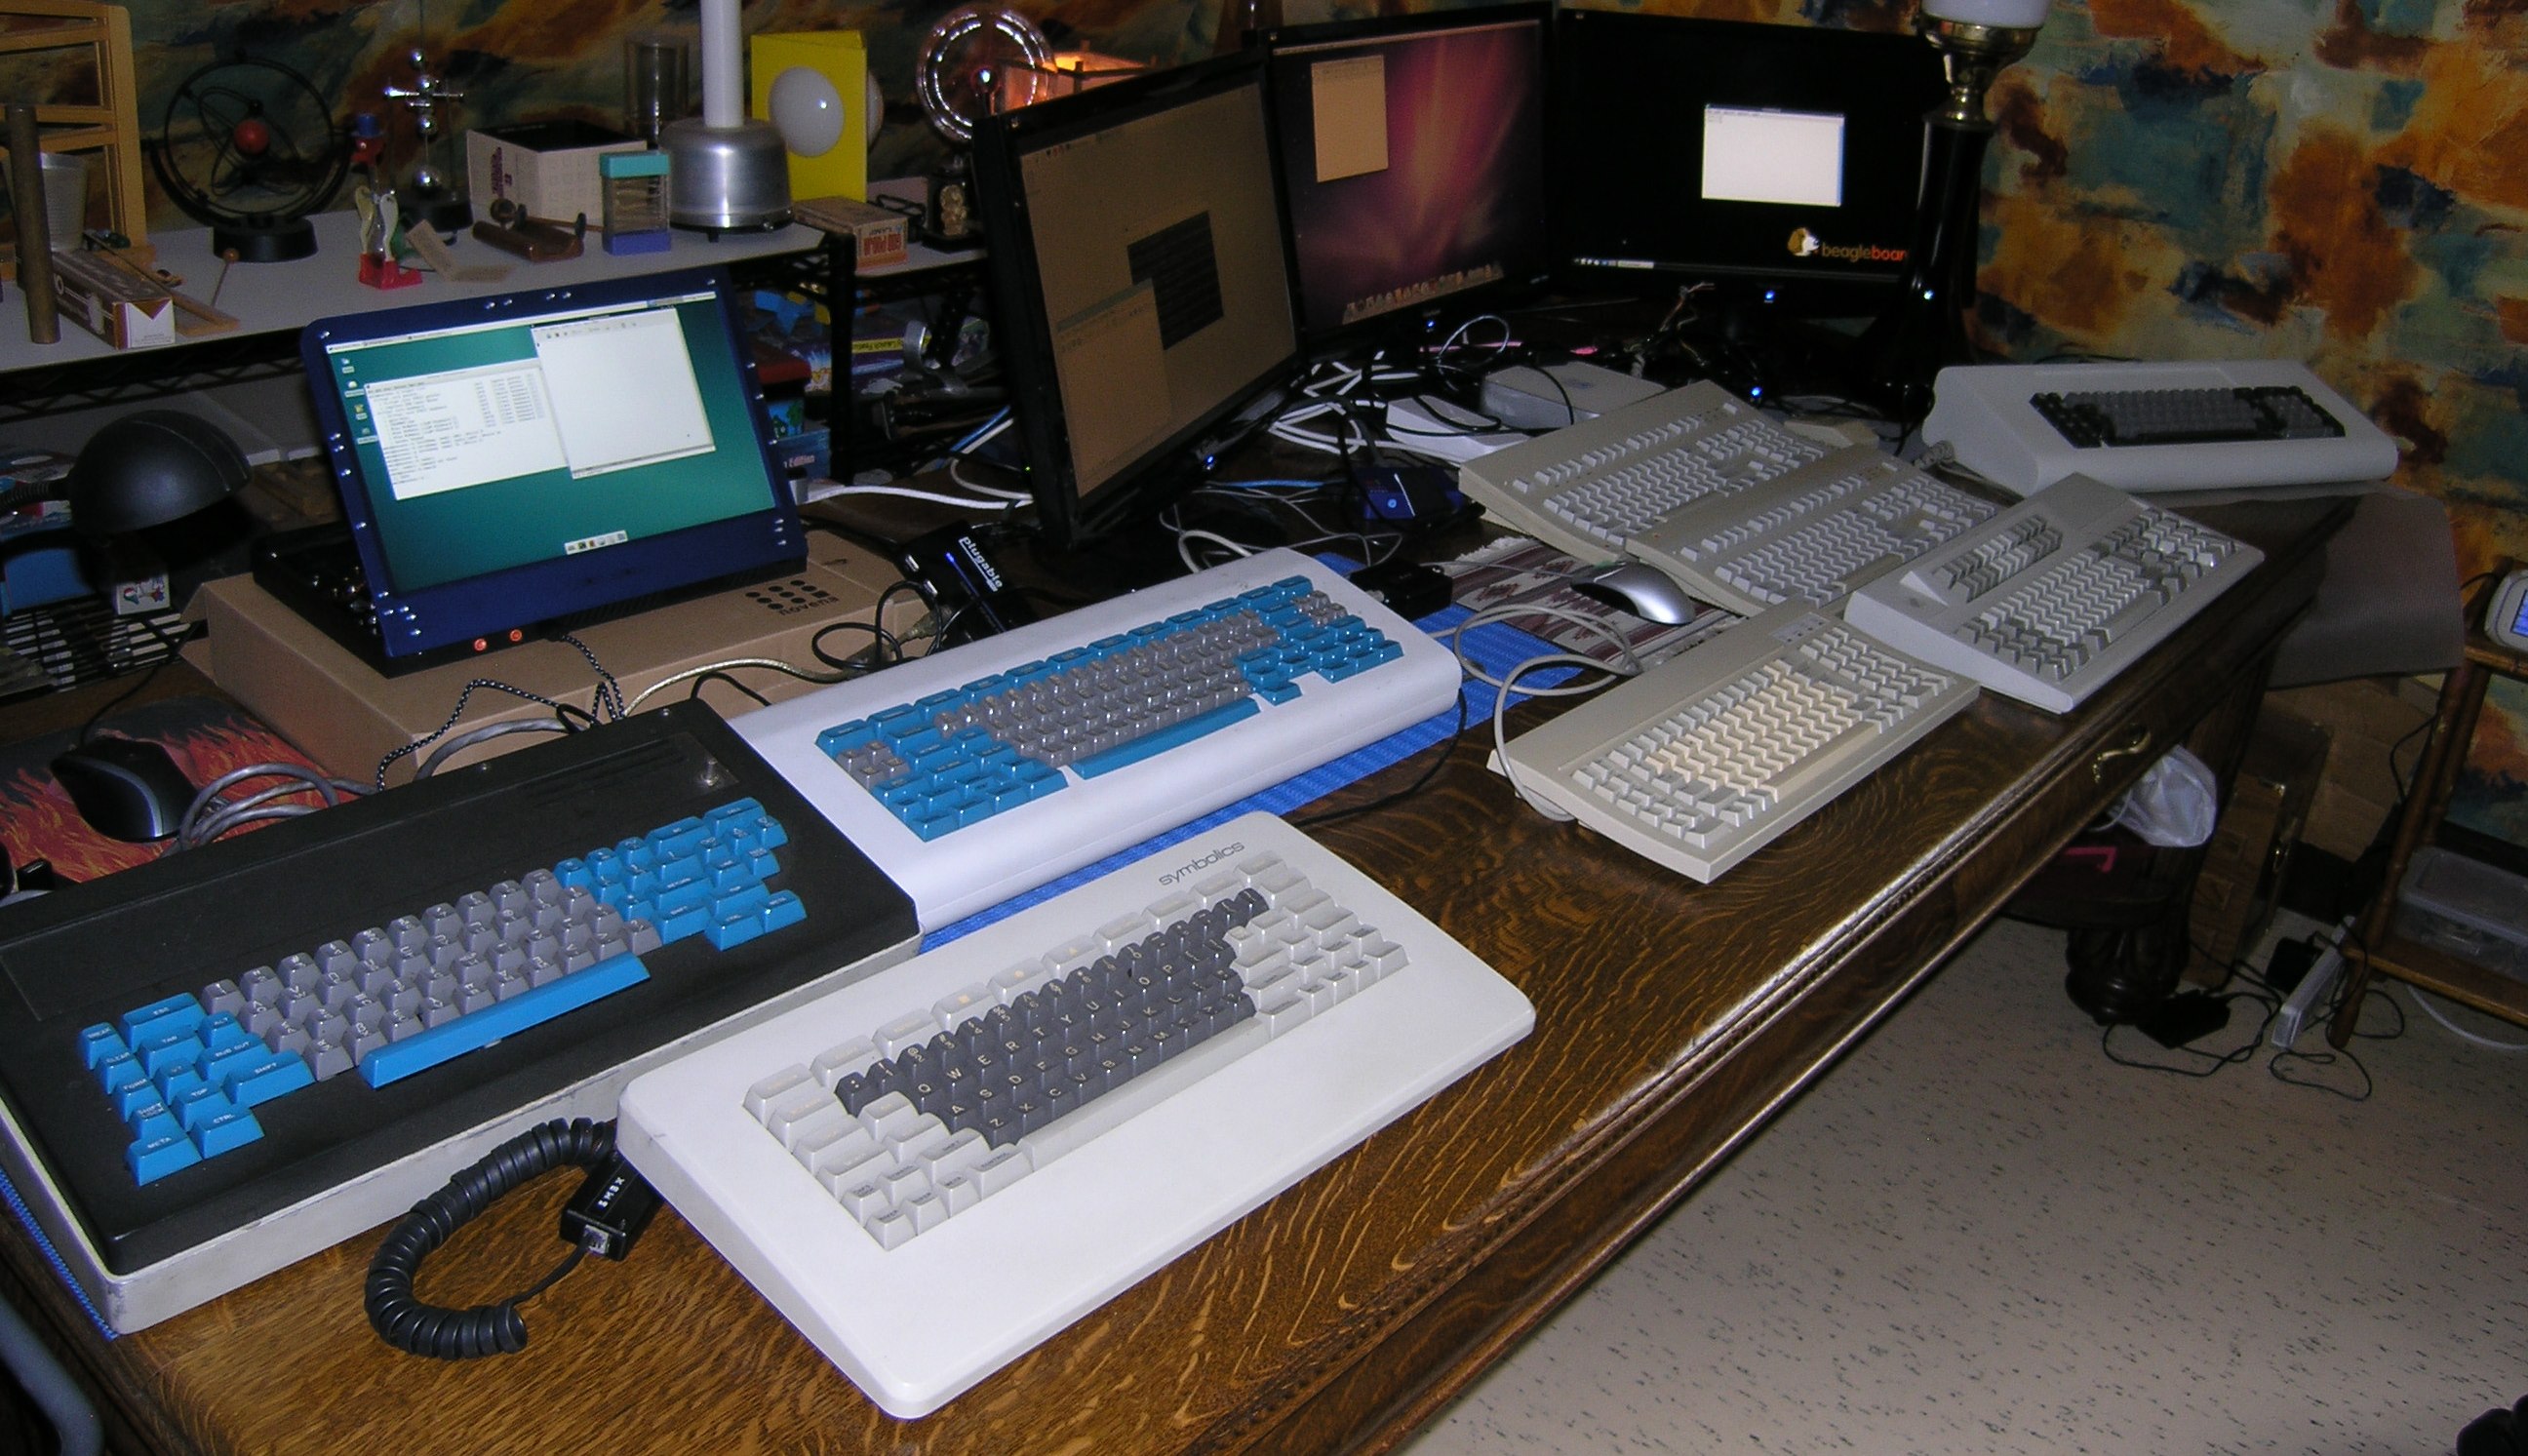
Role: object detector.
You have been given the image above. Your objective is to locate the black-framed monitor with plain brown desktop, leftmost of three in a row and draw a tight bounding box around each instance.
[973,56,1299,548]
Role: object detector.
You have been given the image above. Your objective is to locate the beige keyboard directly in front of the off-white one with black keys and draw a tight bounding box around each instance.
[1843,475,2265,713]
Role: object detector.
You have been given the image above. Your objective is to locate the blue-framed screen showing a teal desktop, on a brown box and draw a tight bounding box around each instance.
[298,273,807,667]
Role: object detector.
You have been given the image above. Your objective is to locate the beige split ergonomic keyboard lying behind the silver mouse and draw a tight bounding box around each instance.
[1459,381,1992,614]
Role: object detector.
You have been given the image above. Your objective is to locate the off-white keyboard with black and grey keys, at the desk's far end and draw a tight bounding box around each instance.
[1921,359,2396,495]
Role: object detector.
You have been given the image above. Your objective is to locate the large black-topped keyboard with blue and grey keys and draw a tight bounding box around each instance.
[0,705,915,1329]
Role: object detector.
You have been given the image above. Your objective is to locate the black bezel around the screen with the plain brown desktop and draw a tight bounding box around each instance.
[970,51,1302,551]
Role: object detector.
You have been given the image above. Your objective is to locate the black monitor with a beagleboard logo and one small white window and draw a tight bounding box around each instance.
[1550,10,1947,313]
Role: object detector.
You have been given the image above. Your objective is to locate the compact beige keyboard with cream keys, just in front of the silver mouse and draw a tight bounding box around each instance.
[1494,607,1974,883]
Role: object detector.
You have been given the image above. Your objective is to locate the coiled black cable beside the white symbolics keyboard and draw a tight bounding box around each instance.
[362,1118,614,1360]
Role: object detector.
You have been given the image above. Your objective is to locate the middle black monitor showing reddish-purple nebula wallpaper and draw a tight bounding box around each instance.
[1264,5,1552,349]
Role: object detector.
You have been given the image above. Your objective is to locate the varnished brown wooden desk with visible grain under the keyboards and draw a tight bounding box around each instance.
[0,492,2339,1456]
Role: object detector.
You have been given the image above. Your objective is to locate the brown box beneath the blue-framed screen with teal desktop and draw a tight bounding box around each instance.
[184,533,923,784]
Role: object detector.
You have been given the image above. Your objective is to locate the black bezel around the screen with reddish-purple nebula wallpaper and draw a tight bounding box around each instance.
[1248,0,1562,359]
